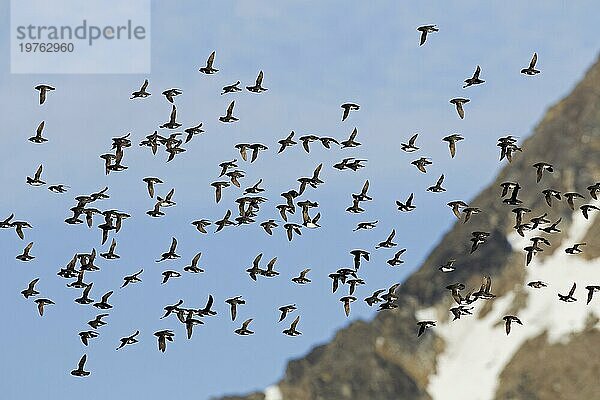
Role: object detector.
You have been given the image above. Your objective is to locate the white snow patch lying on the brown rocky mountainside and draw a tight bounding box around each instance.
[417,201,600,400]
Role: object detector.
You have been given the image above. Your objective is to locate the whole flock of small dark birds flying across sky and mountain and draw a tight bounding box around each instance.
[5,25,600,377]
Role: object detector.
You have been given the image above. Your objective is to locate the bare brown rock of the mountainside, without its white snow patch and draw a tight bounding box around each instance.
[227,56,600,400]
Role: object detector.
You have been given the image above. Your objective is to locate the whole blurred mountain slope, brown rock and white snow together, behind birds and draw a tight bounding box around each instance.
[221,55,600,400]
